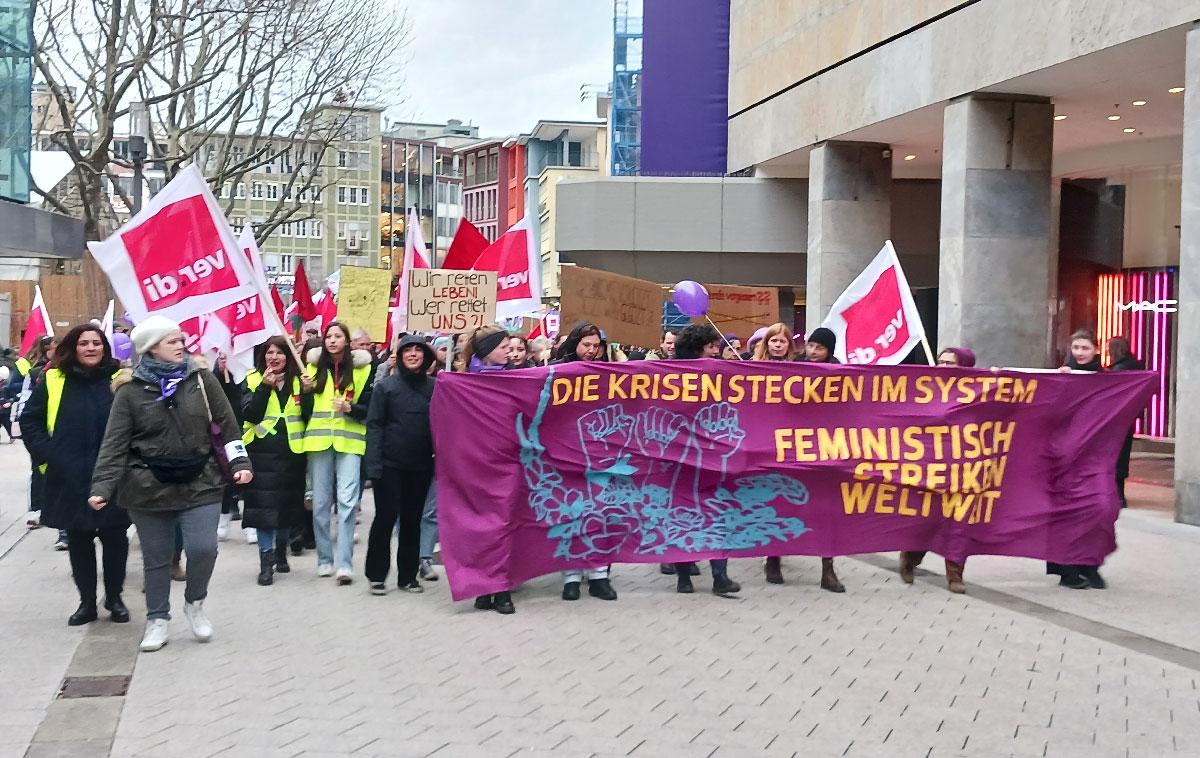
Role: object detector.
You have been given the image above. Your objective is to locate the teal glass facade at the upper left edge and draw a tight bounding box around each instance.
[0,0,34,203]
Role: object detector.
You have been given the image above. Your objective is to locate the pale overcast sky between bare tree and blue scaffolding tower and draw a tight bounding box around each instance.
[388,0,612,137]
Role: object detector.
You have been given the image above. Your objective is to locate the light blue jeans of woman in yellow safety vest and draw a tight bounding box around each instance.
[308,447,361,571]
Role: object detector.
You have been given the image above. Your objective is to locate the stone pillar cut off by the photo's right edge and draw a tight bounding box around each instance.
[1175,20,1200,527]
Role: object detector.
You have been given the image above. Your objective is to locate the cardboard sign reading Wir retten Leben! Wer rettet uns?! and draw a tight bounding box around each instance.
[408,269,497,332]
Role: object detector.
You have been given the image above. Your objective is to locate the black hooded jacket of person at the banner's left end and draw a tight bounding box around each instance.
[366,336,436,480]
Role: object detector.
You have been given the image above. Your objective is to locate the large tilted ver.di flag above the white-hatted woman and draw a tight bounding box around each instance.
[88,166,258,321]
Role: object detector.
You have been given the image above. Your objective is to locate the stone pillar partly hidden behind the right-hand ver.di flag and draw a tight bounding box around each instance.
[805,142,892,331]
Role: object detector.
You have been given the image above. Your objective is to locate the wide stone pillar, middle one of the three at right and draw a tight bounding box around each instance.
[935,95,1058,368]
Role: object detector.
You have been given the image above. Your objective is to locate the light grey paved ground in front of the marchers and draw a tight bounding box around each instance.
[0,450,1200,758]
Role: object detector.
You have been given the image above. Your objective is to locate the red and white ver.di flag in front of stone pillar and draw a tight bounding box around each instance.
[822,240,925,366]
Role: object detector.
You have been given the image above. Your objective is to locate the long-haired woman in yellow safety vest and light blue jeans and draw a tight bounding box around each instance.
[304,321,374,584]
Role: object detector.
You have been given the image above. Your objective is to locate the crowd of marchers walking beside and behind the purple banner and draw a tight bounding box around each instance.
[0,317,1140,651]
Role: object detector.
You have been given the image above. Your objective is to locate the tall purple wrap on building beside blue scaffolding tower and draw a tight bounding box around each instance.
[641,0,730,176]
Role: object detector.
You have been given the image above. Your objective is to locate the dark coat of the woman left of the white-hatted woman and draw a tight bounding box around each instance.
[20,368,130,529]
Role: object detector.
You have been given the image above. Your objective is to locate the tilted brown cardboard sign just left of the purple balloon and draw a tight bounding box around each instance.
[559,266,665,348]
